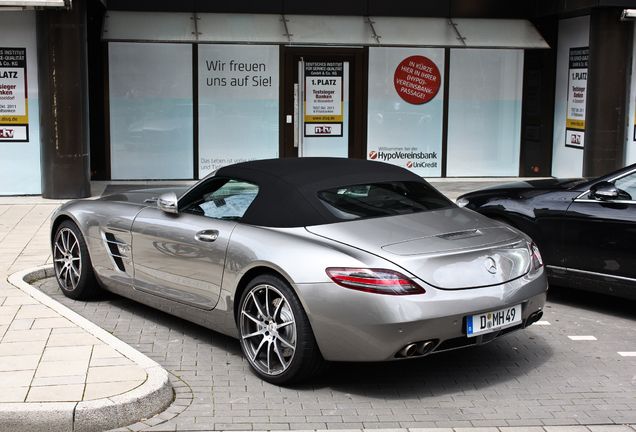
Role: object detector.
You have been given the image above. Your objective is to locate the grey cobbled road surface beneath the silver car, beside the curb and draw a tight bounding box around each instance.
[32,279,636,431]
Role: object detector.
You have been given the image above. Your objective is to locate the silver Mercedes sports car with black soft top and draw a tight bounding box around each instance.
[51,158,548,384]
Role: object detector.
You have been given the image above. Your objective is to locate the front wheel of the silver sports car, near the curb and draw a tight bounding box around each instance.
[53,220,98,299]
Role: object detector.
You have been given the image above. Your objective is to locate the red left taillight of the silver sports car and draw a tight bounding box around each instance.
[327,268,426,295]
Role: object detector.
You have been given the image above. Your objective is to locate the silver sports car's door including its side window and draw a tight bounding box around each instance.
[132,177,258,309]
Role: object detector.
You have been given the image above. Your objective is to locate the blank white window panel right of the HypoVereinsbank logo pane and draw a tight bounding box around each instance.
[446,49,523,177]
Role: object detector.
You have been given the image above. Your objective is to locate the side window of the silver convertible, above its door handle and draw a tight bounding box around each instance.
[179,178,258,222]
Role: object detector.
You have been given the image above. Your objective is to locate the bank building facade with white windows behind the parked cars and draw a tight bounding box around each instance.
[0,0,636,198]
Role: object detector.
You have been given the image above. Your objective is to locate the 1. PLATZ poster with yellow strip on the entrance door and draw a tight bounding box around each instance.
[305,62,344,137]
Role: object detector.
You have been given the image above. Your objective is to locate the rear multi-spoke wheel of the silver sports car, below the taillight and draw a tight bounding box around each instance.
[238,275,325,384]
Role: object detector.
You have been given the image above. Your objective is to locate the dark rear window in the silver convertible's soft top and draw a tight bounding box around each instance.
[318,181,453,219]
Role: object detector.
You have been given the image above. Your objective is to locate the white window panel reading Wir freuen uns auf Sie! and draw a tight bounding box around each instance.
[198,44,279,178]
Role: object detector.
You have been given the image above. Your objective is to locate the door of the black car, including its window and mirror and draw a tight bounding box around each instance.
[563,172,636,284]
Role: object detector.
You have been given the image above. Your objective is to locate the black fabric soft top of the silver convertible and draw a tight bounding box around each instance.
[215,157,432,227]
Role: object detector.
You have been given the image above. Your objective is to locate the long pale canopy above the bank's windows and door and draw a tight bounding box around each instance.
[102,11,549,49]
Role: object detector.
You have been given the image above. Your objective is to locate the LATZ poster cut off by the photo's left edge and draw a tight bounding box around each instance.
[0,48,29,142]
